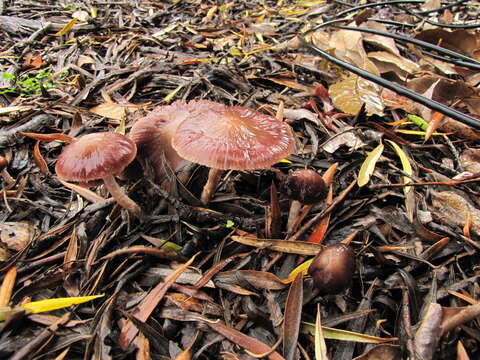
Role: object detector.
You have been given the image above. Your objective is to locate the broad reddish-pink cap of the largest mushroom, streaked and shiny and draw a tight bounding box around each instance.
[172,101,294,170]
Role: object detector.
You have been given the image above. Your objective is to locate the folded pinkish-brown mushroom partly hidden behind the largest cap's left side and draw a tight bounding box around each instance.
[129,101,190,177]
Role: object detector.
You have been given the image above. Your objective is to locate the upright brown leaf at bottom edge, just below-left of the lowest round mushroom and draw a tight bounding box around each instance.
[283,273,303,360]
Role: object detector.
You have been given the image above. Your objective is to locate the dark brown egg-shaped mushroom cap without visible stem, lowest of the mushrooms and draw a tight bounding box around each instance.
[308,243,355,295]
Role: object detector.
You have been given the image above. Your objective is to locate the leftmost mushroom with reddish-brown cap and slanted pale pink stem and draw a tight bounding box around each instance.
[55,132,143,218]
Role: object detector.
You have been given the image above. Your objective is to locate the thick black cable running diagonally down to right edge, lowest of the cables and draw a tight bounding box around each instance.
[301,36,480,130]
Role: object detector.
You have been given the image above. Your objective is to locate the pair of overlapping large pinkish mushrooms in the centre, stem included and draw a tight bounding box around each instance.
[130,100,294,204]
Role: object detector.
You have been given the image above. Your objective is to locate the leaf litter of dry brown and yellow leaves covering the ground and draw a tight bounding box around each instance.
[0,0,480,359]
